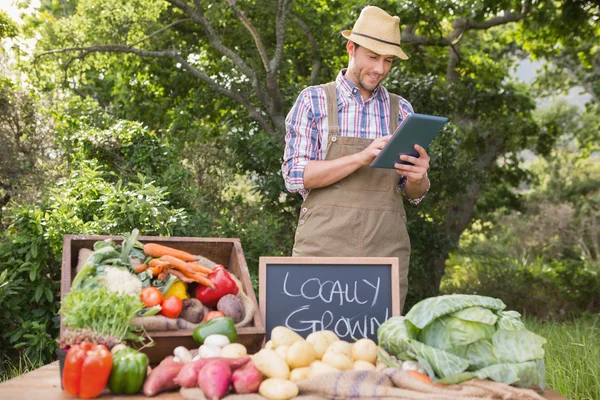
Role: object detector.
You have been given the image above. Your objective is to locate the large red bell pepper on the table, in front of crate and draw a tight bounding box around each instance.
[63,342,112,399]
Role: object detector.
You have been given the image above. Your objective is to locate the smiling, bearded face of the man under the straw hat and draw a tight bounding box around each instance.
[346,42,394,93]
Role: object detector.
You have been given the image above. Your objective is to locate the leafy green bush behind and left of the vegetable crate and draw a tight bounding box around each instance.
[0,161,188,364]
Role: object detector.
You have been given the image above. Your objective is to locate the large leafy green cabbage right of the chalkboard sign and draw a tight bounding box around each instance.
[377,295,546,388]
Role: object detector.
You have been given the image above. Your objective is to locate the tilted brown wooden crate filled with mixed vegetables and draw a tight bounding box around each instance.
[60,235,265,364]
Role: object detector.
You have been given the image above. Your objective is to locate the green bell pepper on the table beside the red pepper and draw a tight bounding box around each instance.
[108,347,149,394]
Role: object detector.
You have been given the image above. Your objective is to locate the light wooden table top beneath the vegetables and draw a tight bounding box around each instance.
[0,361,568,400]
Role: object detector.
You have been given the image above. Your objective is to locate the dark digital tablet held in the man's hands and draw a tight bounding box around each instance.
[371,114,448,169]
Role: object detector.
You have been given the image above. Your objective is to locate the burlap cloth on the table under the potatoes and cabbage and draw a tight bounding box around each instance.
[180,368,544,400]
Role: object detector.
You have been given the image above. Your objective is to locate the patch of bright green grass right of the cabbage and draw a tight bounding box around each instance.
[523,314,600,400]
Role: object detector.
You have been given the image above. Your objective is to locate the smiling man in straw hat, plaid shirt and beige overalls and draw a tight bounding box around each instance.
[282,7,429,309]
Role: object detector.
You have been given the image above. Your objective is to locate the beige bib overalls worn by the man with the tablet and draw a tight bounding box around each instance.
[293,82,410,310]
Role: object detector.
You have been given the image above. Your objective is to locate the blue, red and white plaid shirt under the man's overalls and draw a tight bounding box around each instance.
[281,69,429,205]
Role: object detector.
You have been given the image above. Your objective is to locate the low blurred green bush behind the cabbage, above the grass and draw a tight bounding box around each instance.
[440,249,600,320]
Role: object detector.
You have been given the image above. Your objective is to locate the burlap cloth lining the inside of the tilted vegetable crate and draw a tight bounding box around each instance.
[76,249,255,336]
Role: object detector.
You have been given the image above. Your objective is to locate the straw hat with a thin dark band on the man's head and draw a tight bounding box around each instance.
[342,6,408,60]
